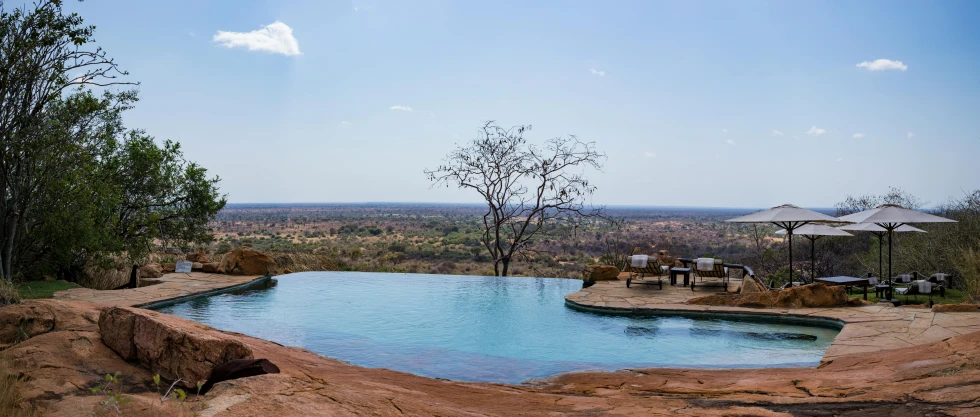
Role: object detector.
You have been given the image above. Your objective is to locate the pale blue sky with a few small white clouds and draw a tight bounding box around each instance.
[67,0,980,207]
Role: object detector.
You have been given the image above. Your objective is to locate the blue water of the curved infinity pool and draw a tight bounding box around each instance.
[158,272,839,383]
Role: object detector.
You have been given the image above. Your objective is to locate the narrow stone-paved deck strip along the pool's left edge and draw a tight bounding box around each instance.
[54,272,262,307]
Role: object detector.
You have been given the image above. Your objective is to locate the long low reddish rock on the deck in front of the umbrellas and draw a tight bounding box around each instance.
[687,282,849,308]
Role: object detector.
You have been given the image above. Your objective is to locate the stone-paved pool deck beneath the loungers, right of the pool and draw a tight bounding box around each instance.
[565,274,980,362]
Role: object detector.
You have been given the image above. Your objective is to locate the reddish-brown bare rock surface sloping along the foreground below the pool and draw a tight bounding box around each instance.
[0,300,980,417]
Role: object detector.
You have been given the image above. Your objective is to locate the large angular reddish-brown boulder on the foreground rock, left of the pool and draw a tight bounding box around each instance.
[99,307,252,388]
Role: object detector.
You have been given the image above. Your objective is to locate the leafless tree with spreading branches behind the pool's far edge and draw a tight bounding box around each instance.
[425,121,605,276]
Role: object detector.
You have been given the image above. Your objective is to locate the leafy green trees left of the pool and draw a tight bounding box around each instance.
[0,0,225,280]
